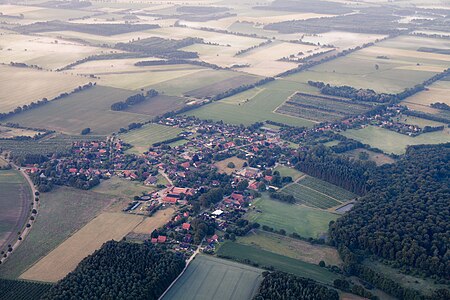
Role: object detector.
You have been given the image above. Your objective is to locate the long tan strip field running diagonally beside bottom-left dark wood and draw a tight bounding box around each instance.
[20,212,143,282]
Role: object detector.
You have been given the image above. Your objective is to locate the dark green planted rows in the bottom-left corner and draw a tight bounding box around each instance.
[0,279,52,300]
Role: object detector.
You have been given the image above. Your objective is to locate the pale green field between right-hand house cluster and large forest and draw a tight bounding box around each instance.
[342,126,450,154]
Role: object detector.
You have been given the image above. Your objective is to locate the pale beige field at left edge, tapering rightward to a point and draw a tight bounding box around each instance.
[0,65,89,113]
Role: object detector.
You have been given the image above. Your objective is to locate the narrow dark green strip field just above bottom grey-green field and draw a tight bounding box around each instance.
[217,242,338,284]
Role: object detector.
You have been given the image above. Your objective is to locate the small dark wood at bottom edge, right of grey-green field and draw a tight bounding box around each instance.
[253,272,339,300]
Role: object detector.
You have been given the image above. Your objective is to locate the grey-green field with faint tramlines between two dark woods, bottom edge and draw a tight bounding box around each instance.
[162,255,262,300]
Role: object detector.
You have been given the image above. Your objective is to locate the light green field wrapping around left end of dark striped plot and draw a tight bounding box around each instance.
[187,80,315,126]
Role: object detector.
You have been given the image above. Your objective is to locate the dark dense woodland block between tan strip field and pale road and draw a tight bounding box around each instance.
[42,241,185,300]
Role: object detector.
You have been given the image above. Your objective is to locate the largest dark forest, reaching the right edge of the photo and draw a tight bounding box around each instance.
[330,144,450,280]
